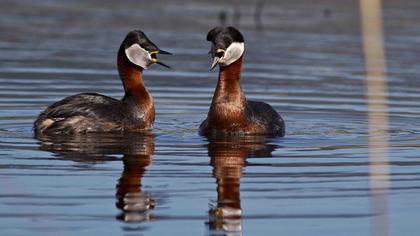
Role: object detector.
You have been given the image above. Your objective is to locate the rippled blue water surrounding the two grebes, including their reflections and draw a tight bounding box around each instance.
[0,0,420,235]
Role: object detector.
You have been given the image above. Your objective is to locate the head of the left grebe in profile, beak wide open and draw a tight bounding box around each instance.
[121,30,172,69]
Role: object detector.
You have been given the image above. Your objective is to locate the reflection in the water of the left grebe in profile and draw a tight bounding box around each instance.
[37,132,155,226]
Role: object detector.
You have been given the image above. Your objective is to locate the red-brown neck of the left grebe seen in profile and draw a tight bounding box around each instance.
[117,48,153,105]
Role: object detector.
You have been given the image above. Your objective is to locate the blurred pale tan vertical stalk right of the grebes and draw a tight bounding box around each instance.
[360,0,389,236]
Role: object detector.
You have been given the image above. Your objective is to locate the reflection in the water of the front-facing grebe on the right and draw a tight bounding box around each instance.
[206,136,277,235]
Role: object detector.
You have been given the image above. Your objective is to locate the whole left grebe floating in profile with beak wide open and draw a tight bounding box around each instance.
[34,30,171,134]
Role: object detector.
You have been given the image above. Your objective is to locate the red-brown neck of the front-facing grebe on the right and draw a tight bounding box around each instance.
[212,56,245,107]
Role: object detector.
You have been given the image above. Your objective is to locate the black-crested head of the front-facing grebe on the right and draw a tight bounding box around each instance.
[207,26,244,70]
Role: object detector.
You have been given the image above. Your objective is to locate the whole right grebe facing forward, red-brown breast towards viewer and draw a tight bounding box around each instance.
[200,27,285,136]
